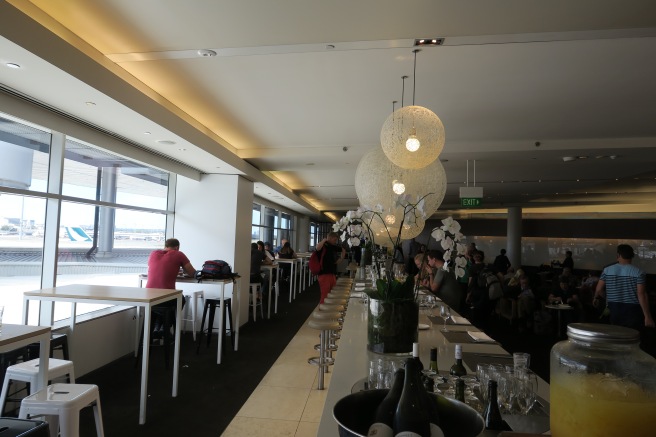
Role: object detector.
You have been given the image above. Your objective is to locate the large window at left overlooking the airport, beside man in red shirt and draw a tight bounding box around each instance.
[0,115,169,324]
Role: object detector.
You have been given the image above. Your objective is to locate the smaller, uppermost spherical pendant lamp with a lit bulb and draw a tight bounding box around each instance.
[380,106,444,169]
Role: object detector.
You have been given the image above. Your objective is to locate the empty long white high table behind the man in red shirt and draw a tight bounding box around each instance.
[23,284,182,425]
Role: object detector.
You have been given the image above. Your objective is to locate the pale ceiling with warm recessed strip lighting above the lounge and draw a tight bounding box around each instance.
[0,0,656,218]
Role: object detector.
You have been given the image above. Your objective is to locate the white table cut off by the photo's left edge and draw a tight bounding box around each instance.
[0,323,50,396]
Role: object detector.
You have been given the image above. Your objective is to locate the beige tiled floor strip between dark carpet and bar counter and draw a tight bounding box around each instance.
[222,308,336,437]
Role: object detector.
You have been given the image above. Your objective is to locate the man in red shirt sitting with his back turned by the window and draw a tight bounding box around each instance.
[146,238,196,338]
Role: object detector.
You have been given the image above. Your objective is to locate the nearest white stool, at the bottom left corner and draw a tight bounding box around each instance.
[18,384,105,437]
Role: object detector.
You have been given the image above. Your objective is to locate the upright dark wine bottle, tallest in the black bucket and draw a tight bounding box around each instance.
[394,358,430,437]
